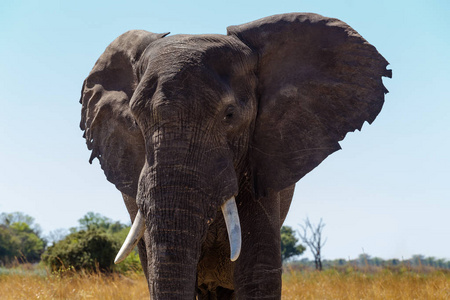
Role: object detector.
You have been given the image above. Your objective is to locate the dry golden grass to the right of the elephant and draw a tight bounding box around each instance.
[282,269,450,300]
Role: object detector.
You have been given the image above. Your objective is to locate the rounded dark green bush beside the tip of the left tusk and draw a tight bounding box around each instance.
[42,229,119,272]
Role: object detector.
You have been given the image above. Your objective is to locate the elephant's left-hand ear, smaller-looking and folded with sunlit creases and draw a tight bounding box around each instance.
[80,30,167,197]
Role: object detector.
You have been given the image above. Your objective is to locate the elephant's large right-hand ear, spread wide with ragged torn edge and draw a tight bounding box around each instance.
[228,13,391,195]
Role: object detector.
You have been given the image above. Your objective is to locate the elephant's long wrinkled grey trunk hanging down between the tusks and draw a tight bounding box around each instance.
[137,153,240,299]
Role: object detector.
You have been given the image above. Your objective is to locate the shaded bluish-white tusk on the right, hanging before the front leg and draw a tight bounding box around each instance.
[221,197,242,261]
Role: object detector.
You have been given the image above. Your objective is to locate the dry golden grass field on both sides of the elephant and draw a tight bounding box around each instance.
[0,267,450,300]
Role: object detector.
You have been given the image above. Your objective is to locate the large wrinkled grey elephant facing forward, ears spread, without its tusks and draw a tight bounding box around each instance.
[81,13,390,299]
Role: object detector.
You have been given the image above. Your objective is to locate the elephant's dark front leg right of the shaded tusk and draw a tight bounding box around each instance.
[234,192,282,299]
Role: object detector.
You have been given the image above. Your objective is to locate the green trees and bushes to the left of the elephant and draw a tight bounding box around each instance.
[0,212,142,272]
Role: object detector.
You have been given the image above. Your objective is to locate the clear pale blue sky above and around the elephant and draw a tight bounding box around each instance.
[0,0,450,259]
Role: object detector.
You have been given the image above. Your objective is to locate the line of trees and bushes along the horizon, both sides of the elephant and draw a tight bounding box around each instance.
[0,212,450,272]
